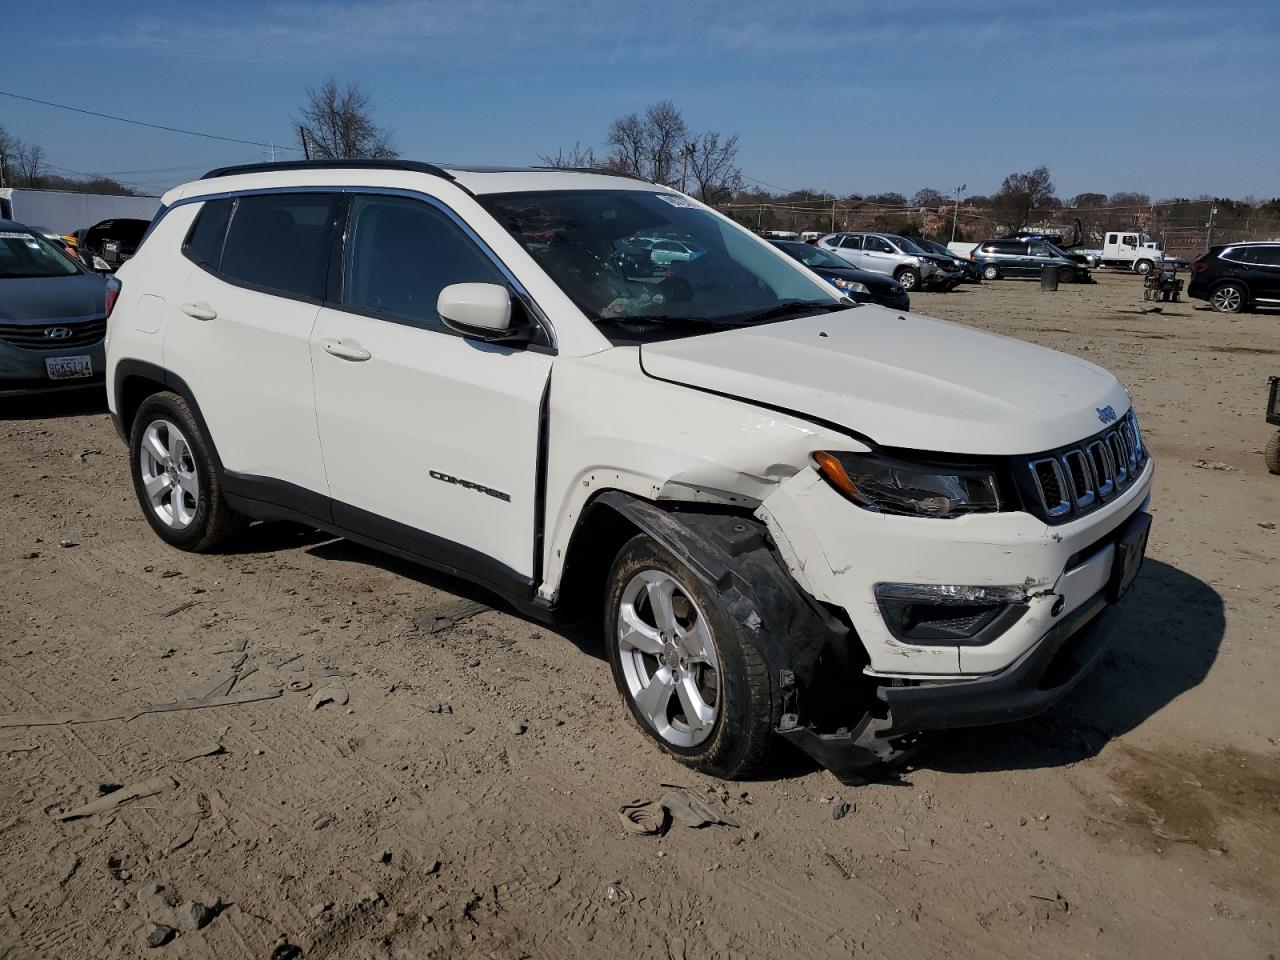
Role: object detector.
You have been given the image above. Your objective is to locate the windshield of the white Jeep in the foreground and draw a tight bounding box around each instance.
[480,189,847,342]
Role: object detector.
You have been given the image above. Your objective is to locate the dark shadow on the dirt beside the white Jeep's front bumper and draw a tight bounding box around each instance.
[913,559,1226,773]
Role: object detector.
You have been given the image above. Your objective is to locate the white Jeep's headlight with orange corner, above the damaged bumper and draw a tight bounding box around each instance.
[813,451,1001,517]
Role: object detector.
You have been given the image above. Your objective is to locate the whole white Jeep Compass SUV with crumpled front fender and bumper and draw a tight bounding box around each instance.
[108,161,1152,780]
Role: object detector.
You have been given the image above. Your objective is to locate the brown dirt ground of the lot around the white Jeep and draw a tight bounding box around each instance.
[0,275,1280,960]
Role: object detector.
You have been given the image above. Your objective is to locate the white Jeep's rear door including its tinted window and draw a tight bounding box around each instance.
[164,192,338,497]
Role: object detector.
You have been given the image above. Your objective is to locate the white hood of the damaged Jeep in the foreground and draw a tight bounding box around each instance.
[640,306,1129,456]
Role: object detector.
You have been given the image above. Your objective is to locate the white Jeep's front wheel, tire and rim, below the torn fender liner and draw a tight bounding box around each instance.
[604,534,781,780]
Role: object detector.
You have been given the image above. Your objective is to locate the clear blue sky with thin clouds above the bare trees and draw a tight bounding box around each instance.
[0,0,1280,198]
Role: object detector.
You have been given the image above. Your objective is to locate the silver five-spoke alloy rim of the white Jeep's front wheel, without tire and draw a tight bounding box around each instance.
[614,570,721,748]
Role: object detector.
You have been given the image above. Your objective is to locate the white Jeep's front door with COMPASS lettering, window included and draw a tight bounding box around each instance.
[311,195,553,590]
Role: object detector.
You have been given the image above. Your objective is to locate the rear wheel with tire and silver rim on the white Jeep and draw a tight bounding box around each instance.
[129,393,244,553]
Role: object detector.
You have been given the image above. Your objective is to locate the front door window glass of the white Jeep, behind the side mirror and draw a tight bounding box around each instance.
[342,196,507,332]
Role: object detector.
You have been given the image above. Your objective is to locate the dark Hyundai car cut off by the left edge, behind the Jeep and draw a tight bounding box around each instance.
[0,220,108,397]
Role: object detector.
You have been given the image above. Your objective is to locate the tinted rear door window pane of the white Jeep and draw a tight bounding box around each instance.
[219,193,338,301]
